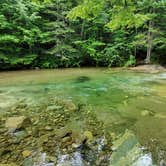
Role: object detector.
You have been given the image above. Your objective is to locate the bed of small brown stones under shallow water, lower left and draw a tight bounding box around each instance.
[0,98,112,166]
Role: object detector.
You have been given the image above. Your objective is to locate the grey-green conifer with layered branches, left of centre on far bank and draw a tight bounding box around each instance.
[38,0,79,68]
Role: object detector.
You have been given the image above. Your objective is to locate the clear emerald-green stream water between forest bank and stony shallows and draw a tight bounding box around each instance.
[0,68,166,165]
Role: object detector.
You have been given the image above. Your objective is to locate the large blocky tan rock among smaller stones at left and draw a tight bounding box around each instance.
[5,116,31,130]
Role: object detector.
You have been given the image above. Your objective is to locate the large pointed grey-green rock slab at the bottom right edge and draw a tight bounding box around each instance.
[109,130,153,166]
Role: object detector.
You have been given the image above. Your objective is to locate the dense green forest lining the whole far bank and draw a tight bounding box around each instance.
[0,0,166,69]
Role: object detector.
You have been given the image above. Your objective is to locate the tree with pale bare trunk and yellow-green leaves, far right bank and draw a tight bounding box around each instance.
[107,0,166,64]
